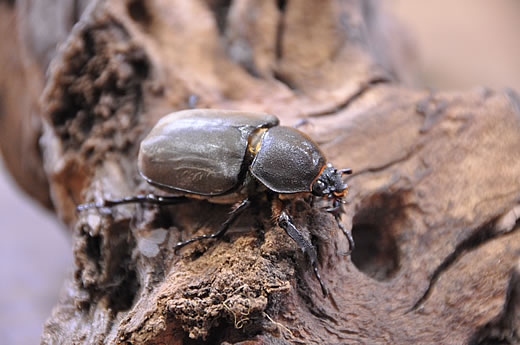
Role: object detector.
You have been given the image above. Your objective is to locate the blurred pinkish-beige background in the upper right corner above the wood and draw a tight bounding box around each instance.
[390,0,520,91]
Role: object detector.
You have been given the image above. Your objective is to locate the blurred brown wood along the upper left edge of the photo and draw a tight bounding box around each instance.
[0,2,52,208]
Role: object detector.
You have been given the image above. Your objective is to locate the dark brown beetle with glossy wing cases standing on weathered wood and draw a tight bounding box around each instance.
[77,109,354,296]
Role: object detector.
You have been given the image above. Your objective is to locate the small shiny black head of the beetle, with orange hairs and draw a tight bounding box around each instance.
[311,163,352,199]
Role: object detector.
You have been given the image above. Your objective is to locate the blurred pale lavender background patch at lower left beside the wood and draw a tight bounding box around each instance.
[0,159,72,345]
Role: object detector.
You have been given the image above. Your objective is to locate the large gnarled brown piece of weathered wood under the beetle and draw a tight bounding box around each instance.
[2,0,520,344]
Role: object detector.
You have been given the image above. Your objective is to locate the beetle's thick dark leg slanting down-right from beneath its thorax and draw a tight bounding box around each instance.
[273,200,328,297]
